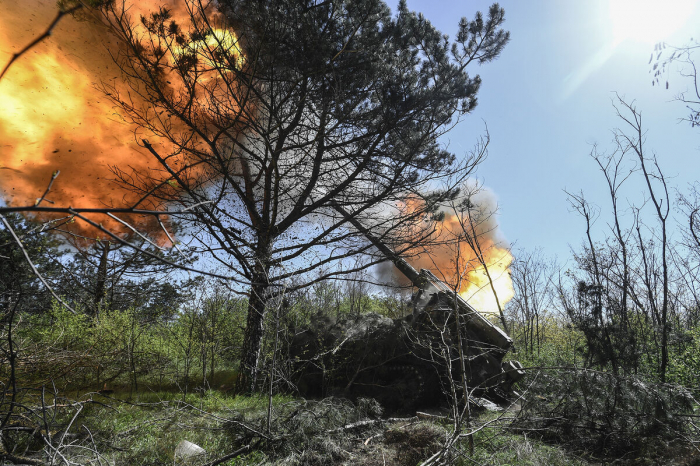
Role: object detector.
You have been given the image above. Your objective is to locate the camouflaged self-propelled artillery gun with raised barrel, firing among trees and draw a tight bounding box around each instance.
[290,211,524,411]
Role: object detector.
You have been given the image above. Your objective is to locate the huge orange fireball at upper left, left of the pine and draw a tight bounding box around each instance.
[0,0,243,243]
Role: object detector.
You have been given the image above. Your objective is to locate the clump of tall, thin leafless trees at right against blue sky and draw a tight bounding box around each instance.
[562,97,675,382]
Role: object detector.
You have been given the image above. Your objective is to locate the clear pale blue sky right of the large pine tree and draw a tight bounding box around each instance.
[392,0,700,260]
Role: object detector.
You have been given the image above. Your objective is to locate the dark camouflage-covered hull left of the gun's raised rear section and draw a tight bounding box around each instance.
[291,313,441,411]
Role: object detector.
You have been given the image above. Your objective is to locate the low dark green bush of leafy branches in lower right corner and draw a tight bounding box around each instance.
[513,368,697,457]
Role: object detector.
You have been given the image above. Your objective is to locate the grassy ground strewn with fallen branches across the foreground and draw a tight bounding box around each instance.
[42,391,587,466]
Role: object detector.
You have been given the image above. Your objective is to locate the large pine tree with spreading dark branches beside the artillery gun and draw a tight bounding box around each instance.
[94,0,509,390]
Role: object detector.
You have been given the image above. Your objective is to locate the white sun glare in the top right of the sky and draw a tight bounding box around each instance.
[610,0,697,44]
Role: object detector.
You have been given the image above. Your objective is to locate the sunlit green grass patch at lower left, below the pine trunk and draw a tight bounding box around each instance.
[73,391,289,465]
